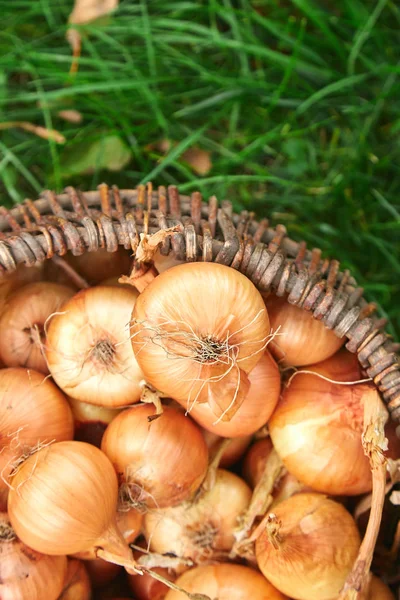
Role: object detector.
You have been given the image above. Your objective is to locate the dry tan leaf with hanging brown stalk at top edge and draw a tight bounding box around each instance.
[67,0,119,74]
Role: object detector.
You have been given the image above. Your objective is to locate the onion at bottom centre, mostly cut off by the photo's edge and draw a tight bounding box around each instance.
[165,563,288,600]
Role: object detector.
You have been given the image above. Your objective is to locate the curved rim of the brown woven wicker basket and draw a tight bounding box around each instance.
[0,184,400,433]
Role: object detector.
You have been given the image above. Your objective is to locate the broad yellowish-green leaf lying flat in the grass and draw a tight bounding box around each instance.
[61,134,132,179]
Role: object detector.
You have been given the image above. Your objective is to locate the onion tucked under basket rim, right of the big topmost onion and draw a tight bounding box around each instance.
[265,294,345,366]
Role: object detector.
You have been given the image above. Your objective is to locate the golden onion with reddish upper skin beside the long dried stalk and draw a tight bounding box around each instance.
[269,351,378,495]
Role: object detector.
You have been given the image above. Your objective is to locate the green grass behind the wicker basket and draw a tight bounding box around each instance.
[0,0,400,338]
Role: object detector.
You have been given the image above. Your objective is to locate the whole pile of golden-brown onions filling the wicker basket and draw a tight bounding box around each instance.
[0,255,400,600]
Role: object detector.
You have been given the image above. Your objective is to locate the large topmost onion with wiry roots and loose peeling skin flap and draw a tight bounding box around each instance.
[131,263,270,420]
